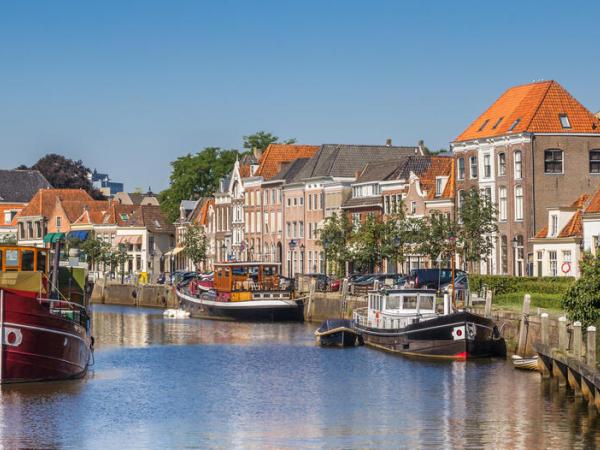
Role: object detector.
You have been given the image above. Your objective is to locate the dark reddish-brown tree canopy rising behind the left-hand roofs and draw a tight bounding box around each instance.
[18,153,104,199]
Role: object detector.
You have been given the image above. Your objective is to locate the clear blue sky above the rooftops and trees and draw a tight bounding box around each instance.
[0,0,600,191]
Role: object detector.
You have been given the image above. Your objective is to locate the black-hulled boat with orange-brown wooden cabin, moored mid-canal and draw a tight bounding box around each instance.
[176,262,304,321]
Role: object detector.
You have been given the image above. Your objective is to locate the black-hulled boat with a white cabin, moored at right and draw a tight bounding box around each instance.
[354,289,506,359]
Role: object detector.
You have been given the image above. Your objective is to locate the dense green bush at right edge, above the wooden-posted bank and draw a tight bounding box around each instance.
[562,252,600,327]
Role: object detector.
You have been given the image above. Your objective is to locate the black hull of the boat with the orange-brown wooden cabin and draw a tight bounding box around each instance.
[177,291,304,322]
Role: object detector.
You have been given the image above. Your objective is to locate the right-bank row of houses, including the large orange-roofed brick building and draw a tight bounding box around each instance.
[180,81,600,276]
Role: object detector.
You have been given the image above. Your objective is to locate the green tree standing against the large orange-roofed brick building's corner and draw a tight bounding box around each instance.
[455,189,498,271]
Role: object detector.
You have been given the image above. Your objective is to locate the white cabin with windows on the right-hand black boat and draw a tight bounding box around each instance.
[355,289,437,329]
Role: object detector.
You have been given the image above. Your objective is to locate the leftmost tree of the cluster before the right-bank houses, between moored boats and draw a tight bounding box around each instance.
[317,213,353,275]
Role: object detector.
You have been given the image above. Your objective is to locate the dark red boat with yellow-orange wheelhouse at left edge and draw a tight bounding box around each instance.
[0,246,93,383]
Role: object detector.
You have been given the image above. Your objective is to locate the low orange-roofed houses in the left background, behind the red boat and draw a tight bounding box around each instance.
[0,170,175,279]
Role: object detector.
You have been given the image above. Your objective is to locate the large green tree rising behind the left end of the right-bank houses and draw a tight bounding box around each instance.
[159,147,240,221]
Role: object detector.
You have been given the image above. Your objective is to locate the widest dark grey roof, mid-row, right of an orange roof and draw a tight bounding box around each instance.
[302,144,420,178]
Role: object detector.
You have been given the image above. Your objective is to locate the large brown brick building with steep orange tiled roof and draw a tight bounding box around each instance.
[451,81,600,275]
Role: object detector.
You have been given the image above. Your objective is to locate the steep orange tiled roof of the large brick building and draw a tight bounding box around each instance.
[455,81,600,142]
